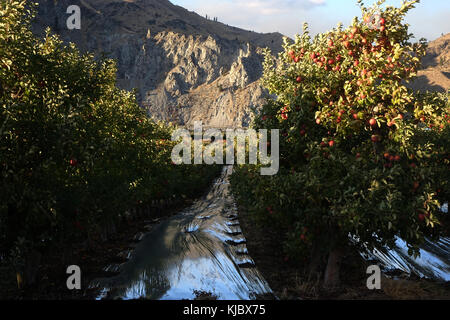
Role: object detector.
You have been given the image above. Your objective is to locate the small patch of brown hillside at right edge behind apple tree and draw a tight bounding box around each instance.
[411,33,450,92]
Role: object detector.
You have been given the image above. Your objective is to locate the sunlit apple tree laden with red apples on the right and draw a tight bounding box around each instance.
[233,0,449,286]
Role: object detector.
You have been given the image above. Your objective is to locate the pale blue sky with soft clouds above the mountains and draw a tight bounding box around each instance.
[171,0,450,41]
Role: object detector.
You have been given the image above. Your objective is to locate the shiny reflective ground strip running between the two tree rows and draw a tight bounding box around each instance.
[91,166,272,300]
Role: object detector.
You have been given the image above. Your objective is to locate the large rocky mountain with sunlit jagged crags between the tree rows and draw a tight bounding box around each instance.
[33,0,283,127]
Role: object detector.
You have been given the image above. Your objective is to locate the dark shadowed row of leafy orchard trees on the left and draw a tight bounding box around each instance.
[0,0,217,260]
